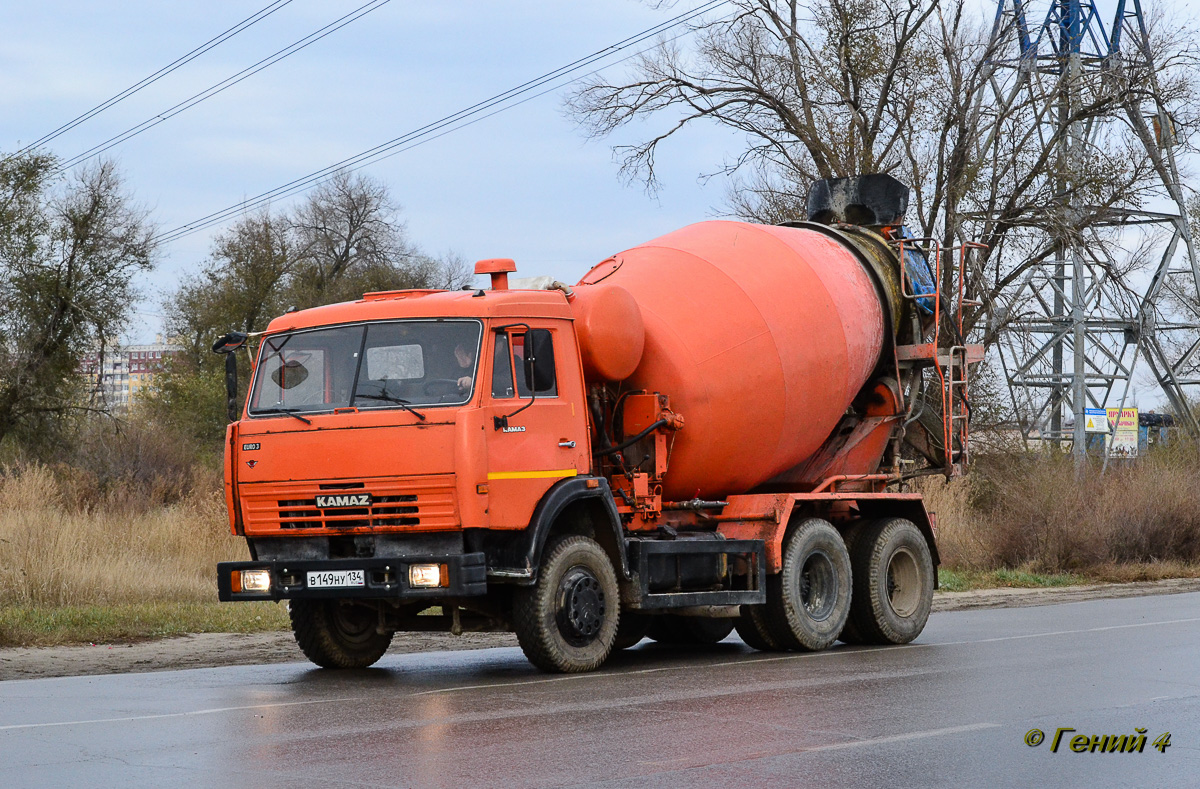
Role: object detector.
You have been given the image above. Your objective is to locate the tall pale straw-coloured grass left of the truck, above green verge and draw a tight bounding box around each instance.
[0,464,248,607]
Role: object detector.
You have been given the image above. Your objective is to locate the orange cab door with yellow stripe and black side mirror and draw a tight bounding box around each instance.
[485,321,589,529]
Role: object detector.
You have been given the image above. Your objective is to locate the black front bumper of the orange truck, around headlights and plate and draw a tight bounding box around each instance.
[217,553,487,602]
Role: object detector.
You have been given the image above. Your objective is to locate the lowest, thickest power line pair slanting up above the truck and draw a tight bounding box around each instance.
[158,0,730,243]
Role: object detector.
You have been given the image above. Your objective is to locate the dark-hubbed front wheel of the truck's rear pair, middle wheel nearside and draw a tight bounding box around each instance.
[762,518,852,652]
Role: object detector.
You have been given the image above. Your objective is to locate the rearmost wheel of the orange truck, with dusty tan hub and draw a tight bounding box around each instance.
[850,518,934,644]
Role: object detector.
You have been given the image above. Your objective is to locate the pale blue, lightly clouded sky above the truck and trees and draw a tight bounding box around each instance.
[0,0,1194,414]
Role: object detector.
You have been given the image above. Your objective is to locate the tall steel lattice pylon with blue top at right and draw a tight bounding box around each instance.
[989,0,1200,458]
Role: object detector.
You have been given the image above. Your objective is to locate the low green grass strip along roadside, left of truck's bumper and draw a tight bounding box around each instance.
[0,602,290,646]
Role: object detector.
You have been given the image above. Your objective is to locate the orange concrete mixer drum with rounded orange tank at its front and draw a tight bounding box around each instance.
[572,221,895,500]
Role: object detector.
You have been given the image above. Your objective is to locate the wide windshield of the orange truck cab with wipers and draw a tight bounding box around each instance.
[248,320,481,415]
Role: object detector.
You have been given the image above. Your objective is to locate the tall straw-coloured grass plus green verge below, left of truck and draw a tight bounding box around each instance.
[0,463,288,646]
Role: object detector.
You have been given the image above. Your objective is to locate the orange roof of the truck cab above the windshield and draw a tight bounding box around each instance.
[266,289,572,333]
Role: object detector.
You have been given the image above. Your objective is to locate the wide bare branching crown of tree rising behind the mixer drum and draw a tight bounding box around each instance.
[566,0,1200,343]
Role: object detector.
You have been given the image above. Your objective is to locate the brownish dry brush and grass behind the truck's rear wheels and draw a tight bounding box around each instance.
[920,446,1200,582]
